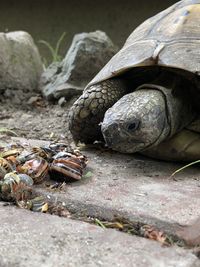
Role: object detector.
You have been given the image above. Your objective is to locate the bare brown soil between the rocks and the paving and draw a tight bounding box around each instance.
[0,91,75,147]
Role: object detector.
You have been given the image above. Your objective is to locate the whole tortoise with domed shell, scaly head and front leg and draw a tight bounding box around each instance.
[69,0,200,161]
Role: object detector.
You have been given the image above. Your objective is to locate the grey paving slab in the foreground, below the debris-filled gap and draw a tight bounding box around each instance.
[0,203,200,267]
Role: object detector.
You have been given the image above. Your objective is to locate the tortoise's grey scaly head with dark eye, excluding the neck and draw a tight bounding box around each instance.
[101,89,170,153]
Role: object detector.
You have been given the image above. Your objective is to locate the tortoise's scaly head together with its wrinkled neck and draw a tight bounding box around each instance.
[101,75,195,153]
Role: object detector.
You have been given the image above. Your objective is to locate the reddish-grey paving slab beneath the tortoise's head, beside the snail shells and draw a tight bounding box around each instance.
[35,150,200,232]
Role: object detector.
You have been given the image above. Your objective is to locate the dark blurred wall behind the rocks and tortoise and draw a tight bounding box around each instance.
[0,0,178,62]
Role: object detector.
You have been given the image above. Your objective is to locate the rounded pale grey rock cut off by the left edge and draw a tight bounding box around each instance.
[0,31,43,91]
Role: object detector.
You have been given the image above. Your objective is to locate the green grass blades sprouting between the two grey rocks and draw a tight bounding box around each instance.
[38,32,66,65]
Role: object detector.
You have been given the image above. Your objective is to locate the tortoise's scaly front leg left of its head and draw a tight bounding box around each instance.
[69,79,128,144]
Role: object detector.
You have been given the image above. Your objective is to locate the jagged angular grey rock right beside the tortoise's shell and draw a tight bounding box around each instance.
[40,31,117,99]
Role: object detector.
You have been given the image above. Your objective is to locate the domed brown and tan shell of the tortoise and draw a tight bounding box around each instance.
[86,0,200,88]
